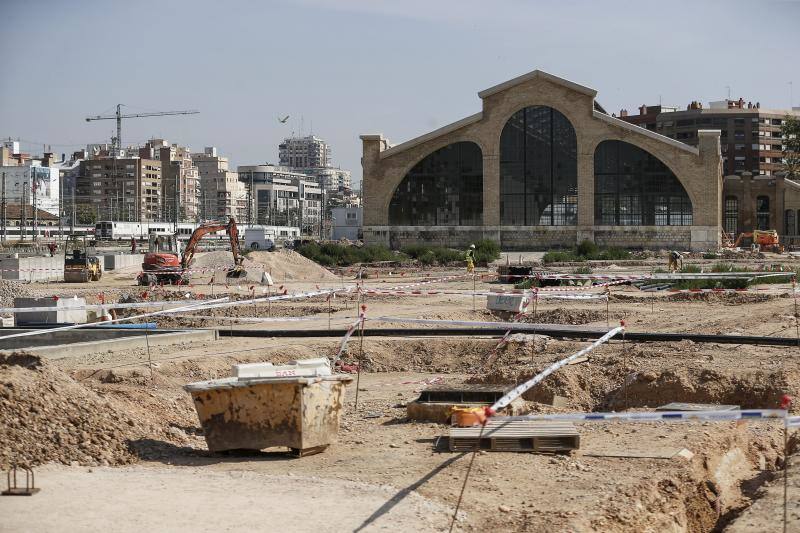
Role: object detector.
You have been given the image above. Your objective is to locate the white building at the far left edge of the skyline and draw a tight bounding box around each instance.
[0,160,60,216]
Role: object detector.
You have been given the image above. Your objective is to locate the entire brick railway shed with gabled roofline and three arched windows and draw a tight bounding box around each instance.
[361,70,722,250]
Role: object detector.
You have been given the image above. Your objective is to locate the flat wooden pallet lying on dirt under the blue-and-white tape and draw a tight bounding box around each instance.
[448,418,580,453]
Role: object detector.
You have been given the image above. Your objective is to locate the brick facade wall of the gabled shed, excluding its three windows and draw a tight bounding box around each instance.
[361,71,722,250]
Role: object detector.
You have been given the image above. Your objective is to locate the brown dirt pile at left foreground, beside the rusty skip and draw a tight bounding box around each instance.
[0,353,193,469]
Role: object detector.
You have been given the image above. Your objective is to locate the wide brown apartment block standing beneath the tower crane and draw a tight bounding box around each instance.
[75,157,162,222]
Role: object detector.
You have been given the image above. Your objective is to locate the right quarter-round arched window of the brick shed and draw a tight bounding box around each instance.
[594,141,692,226]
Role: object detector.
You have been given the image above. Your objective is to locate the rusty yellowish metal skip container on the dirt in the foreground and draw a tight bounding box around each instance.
[184,364,353,456]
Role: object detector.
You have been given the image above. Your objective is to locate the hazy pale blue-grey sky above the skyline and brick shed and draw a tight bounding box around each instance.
[0,0,800,187]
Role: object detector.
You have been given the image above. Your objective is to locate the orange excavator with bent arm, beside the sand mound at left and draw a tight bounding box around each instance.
[137,217,247,285]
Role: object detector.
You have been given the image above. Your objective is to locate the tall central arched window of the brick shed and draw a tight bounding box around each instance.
[500,106,578,226]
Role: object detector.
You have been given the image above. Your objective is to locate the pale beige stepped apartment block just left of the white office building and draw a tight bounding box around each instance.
[191,146,247,220]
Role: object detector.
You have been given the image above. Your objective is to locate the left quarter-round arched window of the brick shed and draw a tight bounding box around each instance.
[389,142,483,226]
